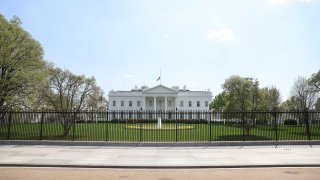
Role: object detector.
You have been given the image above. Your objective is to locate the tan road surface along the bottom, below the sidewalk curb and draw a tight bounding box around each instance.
[0,167,320,180]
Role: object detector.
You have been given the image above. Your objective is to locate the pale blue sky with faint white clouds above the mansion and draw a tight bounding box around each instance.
[0,0,320,100]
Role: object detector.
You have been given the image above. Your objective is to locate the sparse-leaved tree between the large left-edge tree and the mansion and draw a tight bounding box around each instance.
[44,68,96,136]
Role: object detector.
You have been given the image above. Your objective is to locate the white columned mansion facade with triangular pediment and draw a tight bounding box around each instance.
[109,85,212,111]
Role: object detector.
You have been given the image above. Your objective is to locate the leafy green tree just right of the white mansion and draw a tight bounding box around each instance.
[220,76,281,135]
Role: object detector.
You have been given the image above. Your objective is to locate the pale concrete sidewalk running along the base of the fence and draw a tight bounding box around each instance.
[0,145,320,168]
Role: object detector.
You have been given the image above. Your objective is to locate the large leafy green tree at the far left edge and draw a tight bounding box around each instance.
[0,15,46,111]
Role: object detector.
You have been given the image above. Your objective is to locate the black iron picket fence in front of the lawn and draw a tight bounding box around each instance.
[0,111,320,142]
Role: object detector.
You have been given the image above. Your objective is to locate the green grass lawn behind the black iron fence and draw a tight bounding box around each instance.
[0,123,320,142]
